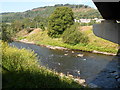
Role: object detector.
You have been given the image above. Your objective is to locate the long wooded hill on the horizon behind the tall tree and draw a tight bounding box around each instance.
[0,4,102,22]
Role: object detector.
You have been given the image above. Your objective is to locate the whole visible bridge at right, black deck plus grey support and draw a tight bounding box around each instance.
[93,0,120,44]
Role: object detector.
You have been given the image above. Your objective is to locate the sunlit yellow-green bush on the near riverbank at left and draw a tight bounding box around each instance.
[2,43,37,72]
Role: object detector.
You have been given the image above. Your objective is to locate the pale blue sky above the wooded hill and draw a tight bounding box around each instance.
[0,0,96,13]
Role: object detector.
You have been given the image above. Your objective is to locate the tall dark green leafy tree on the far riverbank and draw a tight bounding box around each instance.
[48,7,74,38]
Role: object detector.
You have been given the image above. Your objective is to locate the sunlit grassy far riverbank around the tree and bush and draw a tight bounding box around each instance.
[18,26,118,54]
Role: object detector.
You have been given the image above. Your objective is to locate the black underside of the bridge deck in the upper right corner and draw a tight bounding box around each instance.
[93,0,120,21]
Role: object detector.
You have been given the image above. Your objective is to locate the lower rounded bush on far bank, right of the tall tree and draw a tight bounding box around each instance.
[62,25,89,45]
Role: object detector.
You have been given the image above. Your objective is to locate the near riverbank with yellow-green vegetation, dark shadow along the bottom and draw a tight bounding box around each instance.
[0,43,83,89]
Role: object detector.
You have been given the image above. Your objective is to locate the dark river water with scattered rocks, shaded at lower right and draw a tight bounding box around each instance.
[10,42,120,88]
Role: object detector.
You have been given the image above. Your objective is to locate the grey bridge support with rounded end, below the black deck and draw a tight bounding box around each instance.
[93,20,120,45]
